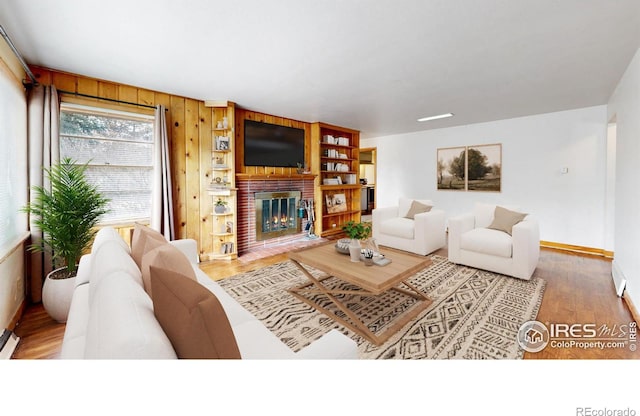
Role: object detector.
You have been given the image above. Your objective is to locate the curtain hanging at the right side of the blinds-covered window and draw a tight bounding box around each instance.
[151,105,175,241]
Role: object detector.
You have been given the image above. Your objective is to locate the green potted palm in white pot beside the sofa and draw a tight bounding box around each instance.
[23,158,109,322]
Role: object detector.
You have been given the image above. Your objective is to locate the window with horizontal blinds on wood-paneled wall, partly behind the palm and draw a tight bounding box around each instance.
[60,103,154,223]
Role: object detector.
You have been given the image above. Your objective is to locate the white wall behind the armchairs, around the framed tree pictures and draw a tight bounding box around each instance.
[361,105,608,249]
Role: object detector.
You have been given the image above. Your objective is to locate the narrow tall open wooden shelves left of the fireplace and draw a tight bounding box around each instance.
[203,102,238,260]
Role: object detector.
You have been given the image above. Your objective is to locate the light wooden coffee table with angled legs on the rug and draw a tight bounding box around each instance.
[289,241,432,345]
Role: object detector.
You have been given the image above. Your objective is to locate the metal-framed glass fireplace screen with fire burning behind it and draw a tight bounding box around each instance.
[255,191,301,241]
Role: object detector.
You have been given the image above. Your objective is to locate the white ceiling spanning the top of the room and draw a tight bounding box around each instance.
[0,0,640,137]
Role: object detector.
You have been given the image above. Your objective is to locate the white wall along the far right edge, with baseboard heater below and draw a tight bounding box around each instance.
[608,49,640,305]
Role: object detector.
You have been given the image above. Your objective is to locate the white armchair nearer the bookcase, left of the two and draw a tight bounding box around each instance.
[372,198,446,256]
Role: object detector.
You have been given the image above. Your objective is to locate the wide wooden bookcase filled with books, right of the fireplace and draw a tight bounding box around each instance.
[311,123,361,237]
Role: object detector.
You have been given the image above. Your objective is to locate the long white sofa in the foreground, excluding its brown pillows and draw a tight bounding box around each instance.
[61,228,358,359]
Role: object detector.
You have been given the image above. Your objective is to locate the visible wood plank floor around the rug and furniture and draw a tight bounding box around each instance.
[12,245,640,359]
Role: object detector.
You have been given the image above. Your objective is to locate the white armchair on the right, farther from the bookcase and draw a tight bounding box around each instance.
[448,203,540,280]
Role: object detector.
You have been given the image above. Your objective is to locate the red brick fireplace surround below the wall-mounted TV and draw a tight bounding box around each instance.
[236,175,315,255]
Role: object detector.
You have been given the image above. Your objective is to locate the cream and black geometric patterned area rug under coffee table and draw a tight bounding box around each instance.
[218,255,546,359]
